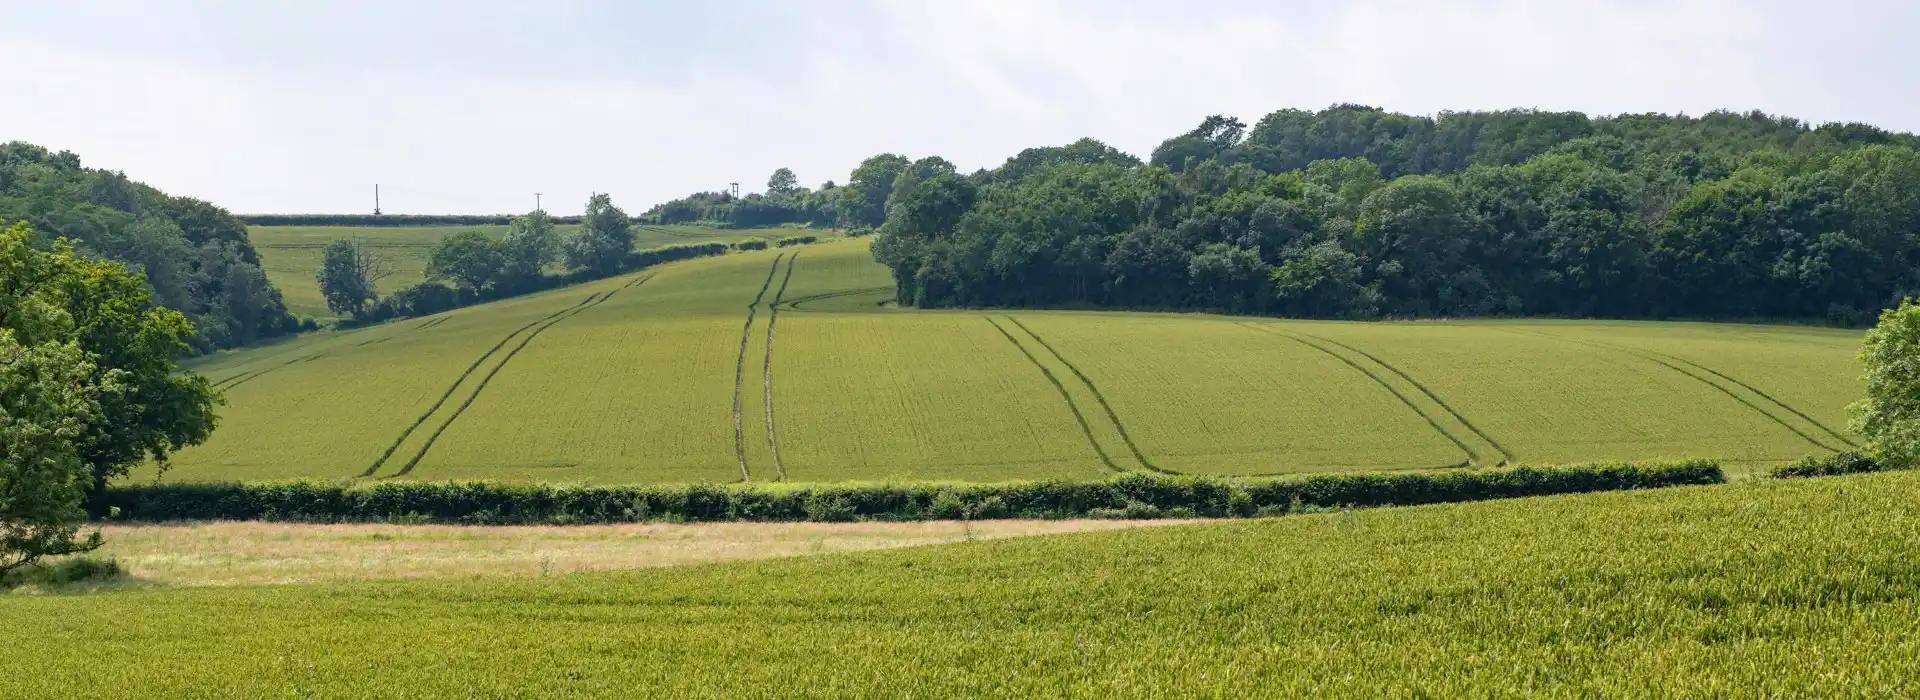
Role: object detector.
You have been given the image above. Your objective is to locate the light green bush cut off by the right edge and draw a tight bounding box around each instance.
[1851,299,1920,466]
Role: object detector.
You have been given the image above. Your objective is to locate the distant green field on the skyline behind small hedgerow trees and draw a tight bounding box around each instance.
[248,224,802,318]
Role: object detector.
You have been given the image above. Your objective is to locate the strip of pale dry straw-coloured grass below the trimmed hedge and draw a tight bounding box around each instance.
[41,520,1179,593]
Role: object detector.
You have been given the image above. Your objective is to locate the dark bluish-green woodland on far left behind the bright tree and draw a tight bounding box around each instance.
[0,142,298,351]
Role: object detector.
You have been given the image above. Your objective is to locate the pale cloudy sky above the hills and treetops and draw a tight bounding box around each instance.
[0,0,1920,213]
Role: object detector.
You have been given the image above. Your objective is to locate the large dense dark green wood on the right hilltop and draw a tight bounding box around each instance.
[875,105,1920,324]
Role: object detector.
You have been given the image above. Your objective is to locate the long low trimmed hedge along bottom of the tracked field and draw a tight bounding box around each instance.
[88,460,1726,524]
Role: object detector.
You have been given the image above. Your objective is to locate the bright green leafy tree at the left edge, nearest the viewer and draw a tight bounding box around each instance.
[0,224,221,577]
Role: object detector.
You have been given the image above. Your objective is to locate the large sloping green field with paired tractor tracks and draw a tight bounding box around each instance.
[167,240,1860,483]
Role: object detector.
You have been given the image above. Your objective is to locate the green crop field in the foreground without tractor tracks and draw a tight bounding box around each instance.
[0,472,1920,698]
